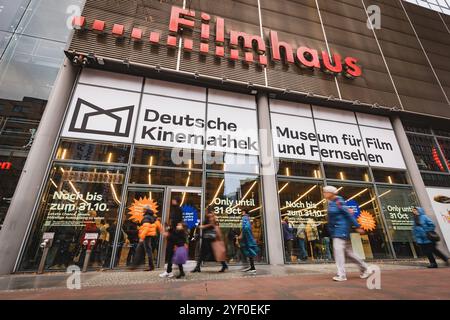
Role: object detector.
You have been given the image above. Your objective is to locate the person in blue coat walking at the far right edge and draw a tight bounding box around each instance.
[413,207,449,268]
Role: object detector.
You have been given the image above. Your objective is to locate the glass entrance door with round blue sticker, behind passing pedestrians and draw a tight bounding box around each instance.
[158,187,203,267]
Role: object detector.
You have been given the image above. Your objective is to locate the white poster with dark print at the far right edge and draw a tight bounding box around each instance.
[427,188,450,251]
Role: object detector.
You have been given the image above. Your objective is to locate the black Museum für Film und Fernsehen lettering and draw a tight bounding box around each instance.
[276,126,394,164]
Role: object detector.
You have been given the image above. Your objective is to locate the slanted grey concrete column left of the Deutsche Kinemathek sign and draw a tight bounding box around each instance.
[0,59,77,274]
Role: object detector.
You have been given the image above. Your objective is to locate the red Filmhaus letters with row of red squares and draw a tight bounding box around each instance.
[73,6,362,78]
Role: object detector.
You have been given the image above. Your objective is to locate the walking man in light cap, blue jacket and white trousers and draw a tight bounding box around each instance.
[323,186,370,281]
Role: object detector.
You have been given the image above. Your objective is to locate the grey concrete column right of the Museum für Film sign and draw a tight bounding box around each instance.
[391,116,449,256]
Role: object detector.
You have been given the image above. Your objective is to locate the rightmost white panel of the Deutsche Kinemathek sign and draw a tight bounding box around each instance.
[206,104,259,155]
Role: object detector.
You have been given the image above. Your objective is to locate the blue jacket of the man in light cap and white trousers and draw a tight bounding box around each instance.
[328,196,361,239]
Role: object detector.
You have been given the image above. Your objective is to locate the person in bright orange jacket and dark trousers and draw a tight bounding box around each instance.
[133,209,162,271]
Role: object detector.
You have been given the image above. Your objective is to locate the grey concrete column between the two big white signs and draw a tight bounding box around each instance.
[256,93,284,265]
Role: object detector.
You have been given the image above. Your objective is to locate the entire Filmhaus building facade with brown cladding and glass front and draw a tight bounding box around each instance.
[0,0,450,273]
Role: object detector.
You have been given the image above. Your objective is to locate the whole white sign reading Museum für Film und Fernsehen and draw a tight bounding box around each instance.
[271,113,405,169]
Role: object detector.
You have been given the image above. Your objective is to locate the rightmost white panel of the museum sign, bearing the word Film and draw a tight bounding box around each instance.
[360,126,406,169]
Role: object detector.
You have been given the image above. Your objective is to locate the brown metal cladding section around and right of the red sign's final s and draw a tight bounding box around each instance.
[319,0,400,107]
